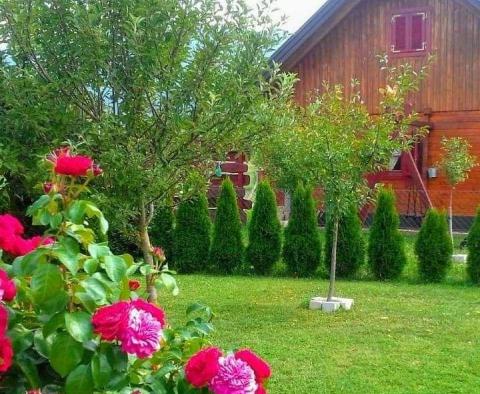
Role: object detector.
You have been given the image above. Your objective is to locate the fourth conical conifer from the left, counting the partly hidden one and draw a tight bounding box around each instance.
[247,181,282,275]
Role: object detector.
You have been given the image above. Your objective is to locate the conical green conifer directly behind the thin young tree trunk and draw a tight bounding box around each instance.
[324,207,365,278]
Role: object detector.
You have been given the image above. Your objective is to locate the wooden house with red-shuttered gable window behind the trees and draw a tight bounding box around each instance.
[273,0,480,227]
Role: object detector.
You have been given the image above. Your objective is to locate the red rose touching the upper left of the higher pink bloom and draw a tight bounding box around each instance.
[92,301,129,341]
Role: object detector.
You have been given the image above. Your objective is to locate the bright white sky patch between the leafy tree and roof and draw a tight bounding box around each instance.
[247,0,326,33]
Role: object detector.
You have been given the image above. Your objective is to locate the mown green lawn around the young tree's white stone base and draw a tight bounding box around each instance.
[162,276,480,394]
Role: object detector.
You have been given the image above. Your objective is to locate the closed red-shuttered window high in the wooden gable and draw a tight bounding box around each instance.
[391,10,428,55]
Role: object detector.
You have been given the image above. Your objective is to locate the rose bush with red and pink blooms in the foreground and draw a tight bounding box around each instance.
[0,148,270,394]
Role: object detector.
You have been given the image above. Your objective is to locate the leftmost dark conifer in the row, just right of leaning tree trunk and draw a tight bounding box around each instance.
[149,201,175,263]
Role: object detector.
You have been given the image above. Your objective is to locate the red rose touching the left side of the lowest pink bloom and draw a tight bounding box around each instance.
[185,347,222,388]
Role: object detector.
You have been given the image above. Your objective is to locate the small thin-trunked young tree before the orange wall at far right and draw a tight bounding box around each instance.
[439,137,477,245]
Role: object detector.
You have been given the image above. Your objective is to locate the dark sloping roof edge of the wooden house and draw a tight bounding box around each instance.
[271,0,480,68]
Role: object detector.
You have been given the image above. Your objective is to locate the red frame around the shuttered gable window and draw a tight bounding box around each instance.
[387,7,432,57]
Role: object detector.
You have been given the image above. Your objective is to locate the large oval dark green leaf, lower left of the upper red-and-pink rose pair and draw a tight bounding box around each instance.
[50,333,83,377]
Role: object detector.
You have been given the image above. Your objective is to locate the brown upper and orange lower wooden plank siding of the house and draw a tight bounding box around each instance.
[287,0,480,216]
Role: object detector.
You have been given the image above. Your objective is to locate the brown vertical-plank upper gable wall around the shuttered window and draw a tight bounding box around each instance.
[291,0,480,113]
